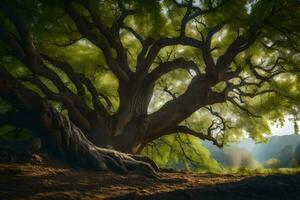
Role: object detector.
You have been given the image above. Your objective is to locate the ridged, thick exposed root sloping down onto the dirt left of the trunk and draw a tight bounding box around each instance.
[42,106,158,177]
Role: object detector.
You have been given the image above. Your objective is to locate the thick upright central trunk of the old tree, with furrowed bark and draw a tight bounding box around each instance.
[95,77,154,154]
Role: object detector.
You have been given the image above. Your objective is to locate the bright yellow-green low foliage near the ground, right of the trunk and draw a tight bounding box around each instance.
[142,134,221,172]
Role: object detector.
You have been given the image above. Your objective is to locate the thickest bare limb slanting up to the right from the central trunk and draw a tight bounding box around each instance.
[146,75,225,141]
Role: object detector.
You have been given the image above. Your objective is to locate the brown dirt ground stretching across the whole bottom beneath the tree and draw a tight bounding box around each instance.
[0,163,300,200]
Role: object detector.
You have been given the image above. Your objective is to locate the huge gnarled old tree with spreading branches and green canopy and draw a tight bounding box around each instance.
[0,0,300,171]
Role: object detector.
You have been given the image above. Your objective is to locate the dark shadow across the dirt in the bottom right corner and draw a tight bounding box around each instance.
[112,174,300,200]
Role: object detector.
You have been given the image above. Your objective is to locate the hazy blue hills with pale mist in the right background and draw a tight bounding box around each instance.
[202,134,300,168]
